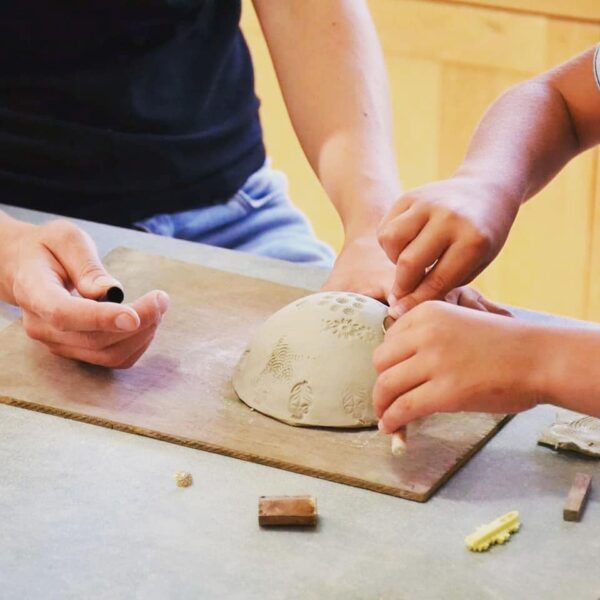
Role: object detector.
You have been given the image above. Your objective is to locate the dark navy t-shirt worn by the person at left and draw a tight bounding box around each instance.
[0,0,265,226]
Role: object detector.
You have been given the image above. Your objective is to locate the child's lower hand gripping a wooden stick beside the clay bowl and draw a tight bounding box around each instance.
[373,302,544,433]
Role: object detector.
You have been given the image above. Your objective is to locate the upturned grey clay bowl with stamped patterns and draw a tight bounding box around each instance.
[233,292,387,427]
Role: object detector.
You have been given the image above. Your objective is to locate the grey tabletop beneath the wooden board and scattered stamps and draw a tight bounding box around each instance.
[0,206,600,600]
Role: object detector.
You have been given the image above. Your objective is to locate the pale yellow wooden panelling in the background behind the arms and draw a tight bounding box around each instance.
[243,0,600,318]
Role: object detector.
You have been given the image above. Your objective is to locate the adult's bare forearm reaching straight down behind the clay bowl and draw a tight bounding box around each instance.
[255,0,400,235]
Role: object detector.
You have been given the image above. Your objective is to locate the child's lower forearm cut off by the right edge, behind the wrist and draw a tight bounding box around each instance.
[538,328,600,417]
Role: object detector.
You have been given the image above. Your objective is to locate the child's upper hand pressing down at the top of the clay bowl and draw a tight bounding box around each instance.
[379,177,518,316]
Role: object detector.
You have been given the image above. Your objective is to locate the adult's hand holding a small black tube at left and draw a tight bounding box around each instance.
[0,213,169,369]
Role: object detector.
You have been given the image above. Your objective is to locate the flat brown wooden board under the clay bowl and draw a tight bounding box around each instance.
[0,248,504,501]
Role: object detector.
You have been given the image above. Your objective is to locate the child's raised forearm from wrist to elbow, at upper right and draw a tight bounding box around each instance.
[458,77,580,205]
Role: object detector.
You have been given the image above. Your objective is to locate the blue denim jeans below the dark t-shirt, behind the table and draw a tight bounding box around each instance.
[135,165,335,267]
